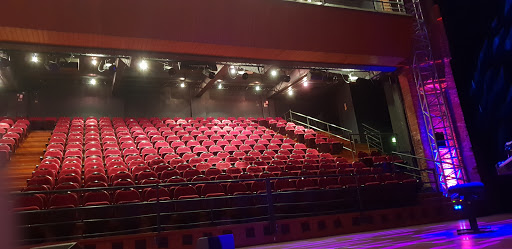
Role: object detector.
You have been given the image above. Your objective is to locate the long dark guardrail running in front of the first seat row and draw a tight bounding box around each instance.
[13,169,418,244]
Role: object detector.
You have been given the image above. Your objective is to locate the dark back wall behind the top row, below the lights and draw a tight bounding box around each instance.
[16,84,268,117]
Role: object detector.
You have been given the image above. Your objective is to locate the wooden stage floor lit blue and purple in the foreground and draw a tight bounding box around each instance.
[245,214,512,249]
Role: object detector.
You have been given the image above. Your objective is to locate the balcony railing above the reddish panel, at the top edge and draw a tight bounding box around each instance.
[285,0,406,14]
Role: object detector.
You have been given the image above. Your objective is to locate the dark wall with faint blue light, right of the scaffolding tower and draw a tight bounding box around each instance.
[439,0,512,211]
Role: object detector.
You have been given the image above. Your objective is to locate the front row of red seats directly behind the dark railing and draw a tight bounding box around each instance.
[18,173,415,211]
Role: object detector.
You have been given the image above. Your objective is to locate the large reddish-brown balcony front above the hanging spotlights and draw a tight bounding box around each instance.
[0,0,412,66]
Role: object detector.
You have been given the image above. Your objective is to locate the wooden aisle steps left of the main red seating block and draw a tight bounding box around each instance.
[7,131,51,191]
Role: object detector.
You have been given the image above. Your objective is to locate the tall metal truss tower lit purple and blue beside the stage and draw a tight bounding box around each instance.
[406,0,466,193]
